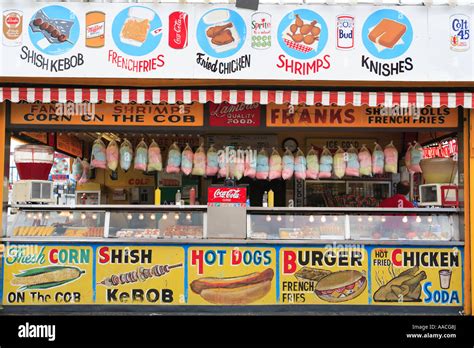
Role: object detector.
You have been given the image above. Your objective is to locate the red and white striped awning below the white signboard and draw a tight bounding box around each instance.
[0,87,474,108]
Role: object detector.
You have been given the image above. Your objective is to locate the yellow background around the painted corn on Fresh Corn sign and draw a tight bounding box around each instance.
[3,244,94,305]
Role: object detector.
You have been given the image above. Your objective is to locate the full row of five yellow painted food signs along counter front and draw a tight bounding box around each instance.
[1,245,464,308]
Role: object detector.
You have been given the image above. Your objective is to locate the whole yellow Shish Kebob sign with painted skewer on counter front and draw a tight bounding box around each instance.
[95,246,185,305]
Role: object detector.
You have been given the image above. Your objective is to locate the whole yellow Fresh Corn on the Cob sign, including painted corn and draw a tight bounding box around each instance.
[3,244,93,305]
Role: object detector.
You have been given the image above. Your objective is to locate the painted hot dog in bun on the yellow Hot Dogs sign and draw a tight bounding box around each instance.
[191,268,274,305]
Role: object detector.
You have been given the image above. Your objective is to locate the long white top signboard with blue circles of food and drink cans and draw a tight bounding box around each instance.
[0,2,473,81]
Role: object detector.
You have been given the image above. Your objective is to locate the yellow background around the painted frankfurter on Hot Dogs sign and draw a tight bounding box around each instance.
[188,246,277,305]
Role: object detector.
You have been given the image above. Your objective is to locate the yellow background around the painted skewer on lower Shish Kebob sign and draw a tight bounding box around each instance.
[95,246,185,305]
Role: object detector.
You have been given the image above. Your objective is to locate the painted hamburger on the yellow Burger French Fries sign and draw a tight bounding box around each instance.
[314,270,367,302]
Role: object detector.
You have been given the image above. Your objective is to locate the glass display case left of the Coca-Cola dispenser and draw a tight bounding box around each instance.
[7,205,207,239]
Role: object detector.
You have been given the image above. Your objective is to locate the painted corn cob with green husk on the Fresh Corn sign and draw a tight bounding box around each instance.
[11,266,85,291]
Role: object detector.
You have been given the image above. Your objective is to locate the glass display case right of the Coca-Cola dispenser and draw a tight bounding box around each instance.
[247,208,461,241]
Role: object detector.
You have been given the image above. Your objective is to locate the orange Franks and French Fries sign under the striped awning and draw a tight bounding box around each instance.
[267,104,458,128]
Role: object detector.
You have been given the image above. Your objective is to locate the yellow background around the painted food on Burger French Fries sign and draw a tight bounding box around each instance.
[278,247,369,305]
